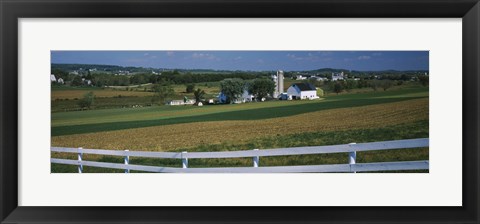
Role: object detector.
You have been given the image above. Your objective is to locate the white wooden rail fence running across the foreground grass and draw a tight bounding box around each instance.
[50,138,429,173]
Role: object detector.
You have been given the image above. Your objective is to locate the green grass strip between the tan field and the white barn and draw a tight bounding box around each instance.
[52,85,428,136]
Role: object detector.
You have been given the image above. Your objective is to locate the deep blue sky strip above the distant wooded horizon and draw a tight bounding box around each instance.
[51,51,429,71]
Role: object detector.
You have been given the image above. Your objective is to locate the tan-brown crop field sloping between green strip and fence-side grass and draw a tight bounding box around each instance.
[51,98,429,151]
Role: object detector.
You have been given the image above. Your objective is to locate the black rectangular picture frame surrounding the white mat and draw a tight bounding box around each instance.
[0,0,480,223]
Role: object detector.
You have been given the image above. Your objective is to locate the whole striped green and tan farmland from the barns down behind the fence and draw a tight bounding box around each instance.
[51,83,429,172]
